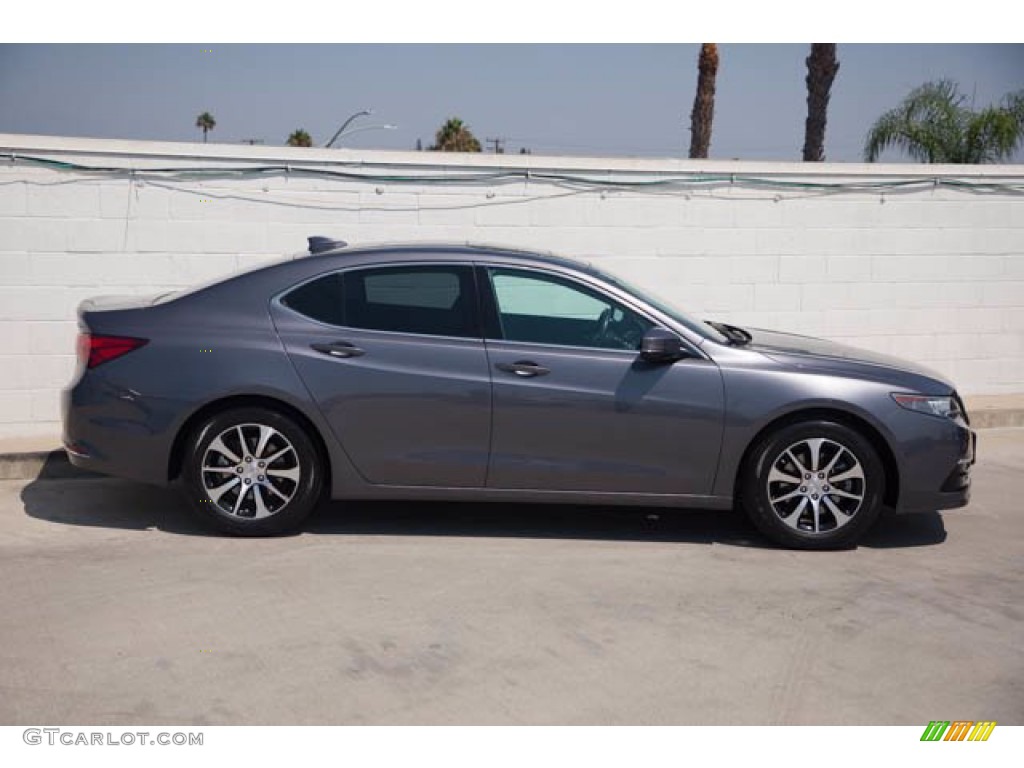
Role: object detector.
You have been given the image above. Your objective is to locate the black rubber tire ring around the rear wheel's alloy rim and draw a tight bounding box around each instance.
[182,408,324,536]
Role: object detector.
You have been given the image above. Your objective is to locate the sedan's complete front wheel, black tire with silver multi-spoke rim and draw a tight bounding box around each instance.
[739,421,885,549]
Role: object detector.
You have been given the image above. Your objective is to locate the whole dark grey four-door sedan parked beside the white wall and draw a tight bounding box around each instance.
[62,238,975,549]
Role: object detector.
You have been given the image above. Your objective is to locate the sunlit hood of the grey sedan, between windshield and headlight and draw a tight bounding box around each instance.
[743,328,955,391]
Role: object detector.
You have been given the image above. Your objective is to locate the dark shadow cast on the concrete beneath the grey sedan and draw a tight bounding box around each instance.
[20,456,946,548]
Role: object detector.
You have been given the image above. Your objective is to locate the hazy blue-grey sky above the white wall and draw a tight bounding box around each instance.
[0,43,1024,162]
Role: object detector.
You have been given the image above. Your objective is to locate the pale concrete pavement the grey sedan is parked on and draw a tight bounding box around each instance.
[0,429,1024,726]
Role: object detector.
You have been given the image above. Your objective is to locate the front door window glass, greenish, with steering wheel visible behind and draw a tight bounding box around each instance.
[488,269,653,349]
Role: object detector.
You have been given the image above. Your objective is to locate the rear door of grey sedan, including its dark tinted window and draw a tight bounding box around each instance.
[272,263,490,487]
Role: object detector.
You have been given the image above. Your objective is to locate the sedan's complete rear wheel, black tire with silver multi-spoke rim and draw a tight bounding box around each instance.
[182,408,325,537]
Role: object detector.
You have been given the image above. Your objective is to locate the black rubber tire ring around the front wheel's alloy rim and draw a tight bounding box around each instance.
[740,420,885,549]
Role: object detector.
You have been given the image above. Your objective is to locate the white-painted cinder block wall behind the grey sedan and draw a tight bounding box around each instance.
[0,134,1024,436]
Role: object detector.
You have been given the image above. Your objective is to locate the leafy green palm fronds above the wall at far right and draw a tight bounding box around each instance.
[864,80,1024,163]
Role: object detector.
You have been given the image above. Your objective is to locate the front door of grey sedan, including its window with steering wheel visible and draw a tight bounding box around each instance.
[479,267,724,496]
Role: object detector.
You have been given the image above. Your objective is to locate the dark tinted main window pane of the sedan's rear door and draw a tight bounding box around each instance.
[344,266,479,337]
